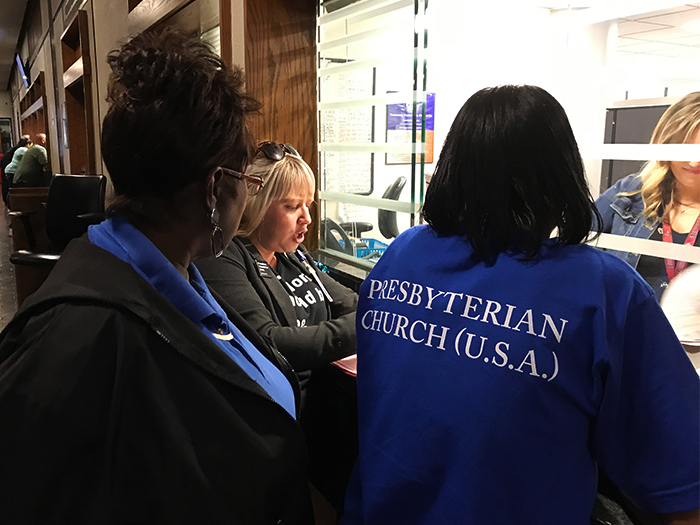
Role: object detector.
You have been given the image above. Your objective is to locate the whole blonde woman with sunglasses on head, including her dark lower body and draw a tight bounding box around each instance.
[197,141,357,511]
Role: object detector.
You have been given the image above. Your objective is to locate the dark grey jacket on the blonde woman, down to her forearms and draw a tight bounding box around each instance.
[196,237,357,372]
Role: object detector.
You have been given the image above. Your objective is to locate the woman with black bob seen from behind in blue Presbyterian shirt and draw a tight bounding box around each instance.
[341,86,700,525]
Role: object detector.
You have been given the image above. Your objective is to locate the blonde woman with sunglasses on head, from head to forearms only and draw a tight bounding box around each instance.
[197,142,357,372]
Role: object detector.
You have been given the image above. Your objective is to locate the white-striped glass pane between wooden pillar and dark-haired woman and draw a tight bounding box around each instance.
[318,0,426,268]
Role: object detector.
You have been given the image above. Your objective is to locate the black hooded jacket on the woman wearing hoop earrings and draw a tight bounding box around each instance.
[0,237,306,524]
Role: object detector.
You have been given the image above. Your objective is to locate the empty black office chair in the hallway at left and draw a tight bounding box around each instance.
[9,174,106,267]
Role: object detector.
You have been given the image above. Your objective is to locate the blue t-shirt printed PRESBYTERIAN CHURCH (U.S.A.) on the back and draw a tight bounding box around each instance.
[341,226,700,525]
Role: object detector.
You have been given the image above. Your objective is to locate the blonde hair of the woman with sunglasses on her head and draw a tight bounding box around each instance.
[236,148,316,237]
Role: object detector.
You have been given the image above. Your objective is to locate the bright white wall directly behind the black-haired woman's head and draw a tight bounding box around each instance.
[429,0,617,199]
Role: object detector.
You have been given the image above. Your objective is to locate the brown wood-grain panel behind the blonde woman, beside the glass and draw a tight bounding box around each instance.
[245,0,318,249]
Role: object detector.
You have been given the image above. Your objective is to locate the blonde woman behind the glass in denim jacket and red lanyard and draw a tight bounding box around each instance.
[596,92,700,299]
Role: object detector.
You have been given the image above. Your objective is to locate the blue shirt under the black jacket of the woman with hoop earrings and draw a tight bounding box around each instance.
[88,217,296,418]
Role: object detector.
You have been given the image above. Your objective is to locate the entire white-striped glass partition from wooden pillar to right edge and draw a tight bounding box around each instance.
[318,0,700,332]
